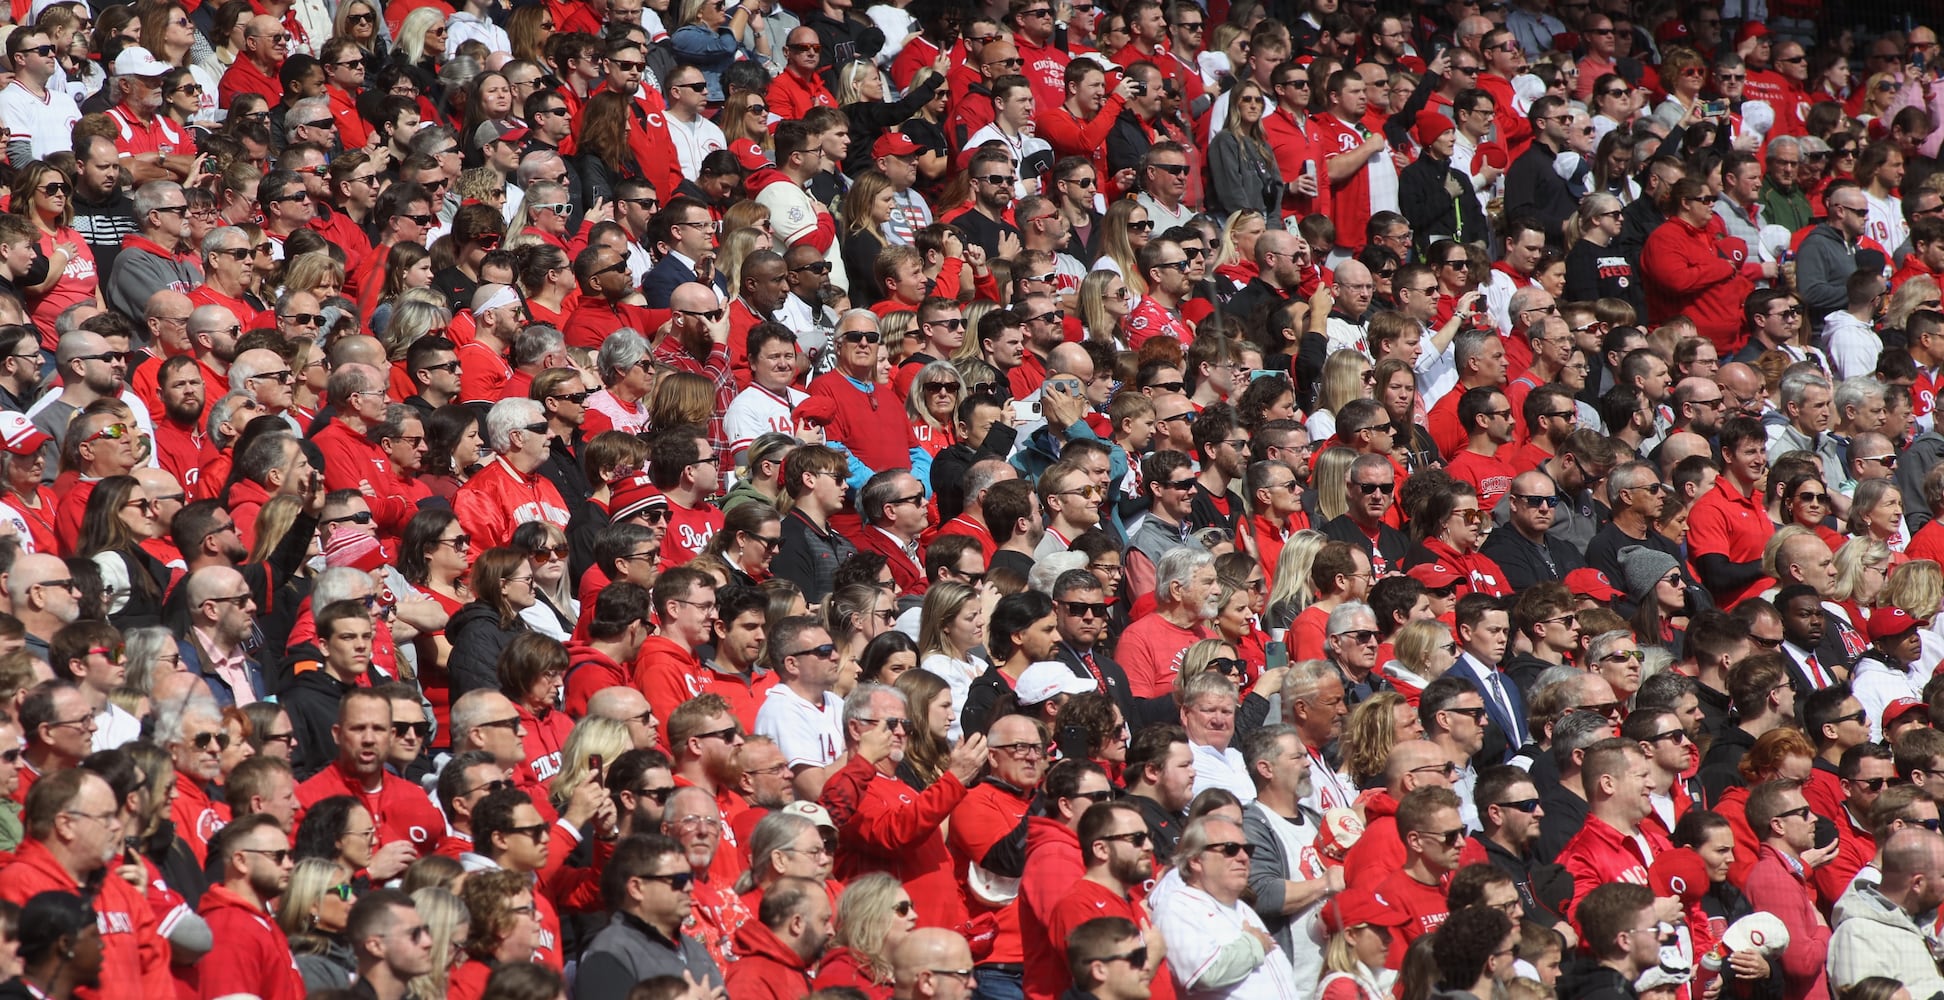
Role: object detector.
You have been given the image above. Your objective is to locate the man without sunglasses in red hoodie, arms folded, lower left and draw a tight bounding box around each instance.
[297,689,445,856]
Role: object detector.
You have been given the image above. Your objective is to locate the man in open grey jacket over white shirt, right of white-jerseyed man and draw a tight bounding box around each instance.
[1242,724,1345,982]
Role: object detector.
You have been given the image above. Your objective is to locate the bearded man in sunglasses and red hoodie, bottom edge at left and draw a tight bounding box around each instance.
[196,813,305,1000]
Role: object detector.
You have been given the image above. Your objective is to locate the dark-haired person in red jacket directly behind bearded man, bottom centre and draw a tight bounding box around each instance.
[1017,761,1114,1000]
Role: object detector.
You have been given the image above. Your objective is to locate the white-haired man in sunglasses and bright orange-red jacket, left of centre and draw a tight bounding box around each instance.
[453,399,568,551]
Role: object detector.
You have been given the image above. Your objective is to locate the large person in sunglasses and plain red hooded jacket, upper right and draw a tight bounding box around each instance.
[1641,177,1773,356]
